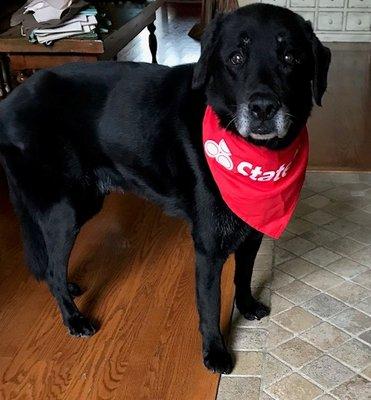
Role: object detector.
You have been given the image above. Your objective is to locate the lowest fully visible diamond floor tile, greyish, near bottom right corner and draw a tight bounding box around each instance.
[301,355,355,389]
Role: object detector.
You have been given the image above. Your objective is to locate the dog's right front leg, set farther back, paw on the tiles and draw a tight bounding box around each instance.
[234,235,270,320]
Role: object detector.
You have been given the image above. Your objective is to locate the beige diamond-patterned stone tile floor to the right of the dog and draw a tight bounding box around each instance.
[217,172,371,400]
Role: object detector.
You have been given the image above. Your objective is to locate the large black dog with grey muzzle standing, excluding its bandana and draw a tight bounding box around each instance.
[0,4,330,373]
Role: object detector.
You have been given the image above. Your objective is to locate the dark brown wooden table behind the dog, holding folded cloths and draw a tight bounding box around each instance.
[0,0,165,97]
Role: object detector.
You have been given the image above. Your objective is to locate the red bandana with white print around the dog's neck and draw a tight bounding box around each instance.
[203,106,309,239]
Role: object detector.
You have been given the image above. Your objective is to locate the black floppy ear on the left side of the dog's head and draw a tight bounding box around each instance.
[192,14,224,89]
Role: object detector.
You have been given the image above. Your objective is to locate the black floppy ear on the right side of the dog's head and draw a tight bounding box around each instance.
[307,22,331,106]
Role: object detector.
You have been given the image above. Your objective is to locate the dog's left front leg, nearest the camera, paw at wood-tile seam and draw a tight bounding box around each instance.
[196,250,233,374]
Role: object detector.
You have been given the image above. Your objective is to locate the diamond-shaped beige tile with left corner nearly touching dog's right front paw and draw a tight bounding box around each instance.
[272,307,321,333]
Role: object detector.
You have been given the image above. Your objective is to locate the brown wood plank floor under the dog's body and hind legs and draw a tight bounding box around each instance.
[0,170,233,400]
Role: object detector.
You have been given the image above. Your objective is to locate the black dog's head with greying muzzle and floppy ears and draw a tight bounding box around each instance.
[193,4,331,148]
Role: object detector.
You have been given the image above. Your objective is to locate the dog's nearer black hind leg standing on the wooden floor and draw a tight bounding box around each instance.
[16,192,99,336]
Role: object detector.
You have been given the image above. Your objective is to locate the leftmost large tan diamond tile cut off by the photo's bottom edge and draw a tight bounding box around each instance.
[267,373,323,400]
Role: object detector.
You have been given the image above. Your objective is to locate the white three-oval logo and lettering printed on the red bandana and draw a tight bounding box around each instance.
[204,139,298,182]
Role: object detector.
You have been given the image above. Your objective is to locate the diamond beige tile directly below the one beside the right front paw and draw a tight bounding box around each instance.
[271,337,322,368]
